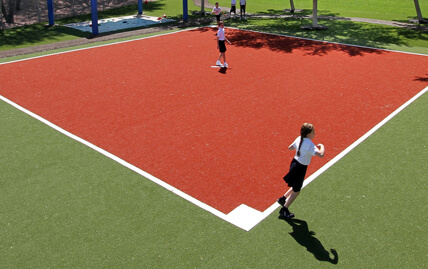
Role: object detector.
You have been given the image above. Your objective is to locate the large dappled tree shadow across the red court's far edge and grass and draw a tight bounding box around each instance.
[221,17,428,56]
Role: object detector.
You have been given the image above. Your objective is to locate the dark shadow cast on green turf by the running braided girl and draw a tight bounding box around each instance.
[279,216,339,264]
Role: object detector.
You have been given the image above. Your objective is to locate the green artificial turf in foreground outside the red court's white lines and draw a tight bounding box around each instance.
[0,3,428,268]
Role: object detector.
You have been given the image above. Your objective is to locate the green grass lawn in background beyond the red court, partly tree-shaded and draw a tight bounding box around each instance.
[0,0,428,51]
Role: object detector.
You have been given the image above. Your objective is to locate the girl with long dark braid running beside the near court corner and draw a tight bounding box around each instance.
[277,123,325,218]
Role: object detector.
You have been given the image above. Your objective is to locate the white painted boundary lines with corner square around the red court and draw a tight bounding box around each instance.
[0,28,428,231]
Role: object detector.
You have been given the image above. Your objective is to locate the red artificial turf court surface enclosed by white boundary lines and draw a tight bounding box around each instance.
[0,28,428,214]
